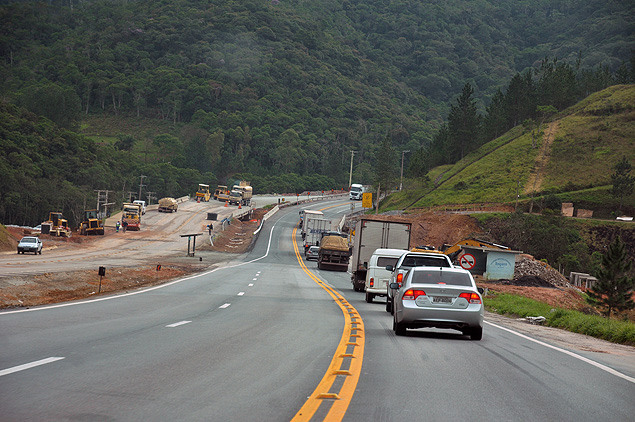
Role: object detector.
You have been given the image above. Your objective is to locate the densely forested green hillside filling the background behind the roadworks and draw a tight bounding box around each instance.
[0,0,635,227]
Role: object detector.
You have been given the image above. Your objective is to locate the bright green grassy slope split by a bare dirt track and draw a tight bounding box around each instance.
[382,85,635,213]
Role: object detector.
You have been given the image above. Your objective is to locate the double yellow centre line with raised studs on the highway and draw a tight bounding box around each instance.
[291,227,365,422]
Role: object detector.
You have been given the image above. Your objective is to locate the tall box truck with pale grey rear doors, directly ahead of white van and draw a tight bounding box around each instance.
[351,217,411,292]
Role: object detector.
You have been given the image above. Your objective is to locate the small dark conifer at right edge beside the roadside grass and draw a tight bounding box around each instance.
[587,236,635,318]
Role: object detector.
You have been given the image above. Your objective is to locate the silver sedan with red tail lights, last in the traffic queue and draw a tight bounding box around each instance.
[390,267,483,340]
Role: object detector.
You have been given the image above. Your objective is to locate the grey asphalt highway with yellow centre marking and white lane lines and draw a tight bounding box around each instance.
[0,201,635,421]
